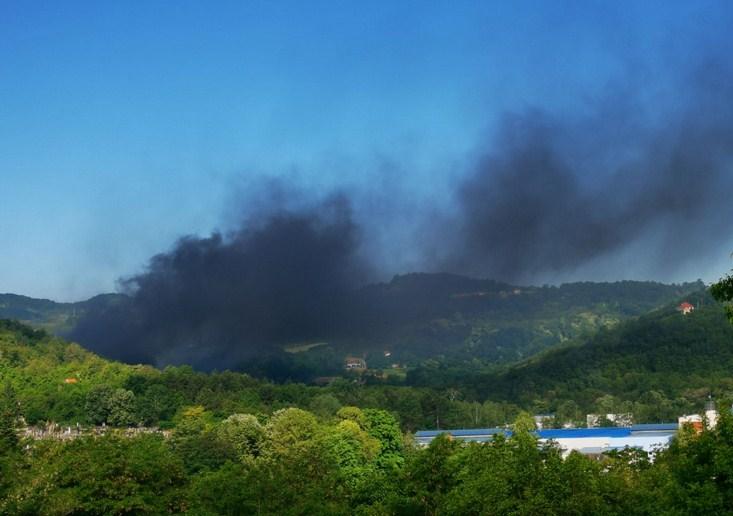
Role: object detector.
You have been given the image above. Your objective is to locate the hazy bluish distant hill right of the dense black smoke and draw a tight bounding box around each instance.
[344,274,704,363]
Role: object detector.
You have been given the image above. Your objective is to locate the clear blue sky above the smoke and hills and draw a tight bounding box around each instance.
[0,1,730,300]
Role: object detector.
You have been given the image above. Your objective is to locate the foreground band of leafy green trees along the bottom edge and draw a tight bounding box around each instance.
[0,394,733,515]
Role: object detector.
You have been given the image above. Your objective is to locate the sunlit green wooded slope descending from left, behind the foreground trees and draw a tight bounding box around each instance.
[0,321,519,431]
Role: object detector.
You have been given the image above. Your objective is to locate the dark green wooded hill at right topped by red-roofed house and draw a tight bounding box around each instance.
[477,292,733,418]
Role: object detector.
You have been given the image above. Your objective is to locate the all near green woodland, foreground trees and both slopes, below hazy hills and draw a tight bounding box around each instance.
[0,280,733,515]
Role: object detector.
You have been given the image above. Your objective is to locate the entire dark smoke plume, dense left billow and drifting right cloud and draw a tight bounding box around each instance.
[73,58,733,367]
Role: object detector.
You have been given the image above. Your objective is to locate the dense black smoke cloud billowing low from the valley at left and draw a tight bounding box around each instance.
[73,192,369,368]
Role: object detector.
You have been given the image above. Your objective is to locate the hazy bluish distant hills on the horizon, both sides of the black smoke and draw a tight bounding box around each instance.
[0,274,704,372]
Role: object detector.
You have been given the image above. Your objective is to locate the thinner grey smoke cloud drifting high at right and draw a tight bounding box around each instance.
[442,62,733,281]
